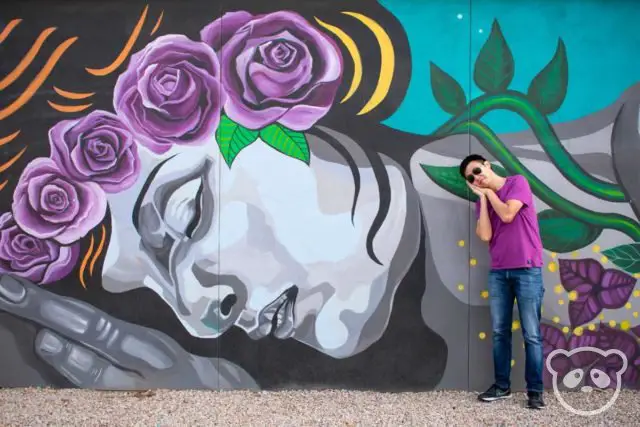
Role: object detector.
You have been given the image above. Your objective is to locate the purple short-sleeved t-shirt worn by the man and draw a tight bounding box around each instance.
[476,175,543,270]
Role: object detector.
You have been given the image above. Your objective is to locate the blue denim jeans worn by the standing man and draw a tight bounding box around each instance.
[489,267,544,392]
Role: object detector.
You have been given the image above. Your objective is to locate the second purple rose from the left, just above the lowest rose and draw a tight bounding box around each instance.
[12,158,107,245]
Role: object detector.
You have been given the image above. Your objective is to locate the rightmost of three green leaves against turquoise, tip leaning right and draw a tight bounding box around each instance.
[527,39,569,114]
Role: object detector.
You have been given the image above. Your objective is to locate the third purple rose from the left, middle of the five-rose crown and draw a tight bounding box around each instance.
[49,110,140,193]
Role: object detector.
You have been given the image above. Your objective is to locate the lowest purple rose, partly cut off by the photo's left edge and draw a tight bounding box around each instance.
[0,212,80,285]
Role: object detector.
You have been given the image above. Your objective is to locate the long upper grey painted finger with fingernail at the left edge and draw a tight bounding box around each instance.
[0,275,178,372]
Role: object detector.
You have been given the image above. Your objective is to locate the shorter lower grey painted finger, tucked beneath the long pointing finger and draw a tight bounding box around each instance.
[35,329,144,390]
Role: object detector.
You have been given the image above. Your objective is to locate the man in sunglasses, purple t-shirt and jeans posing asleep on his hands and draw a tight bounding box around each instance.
[460,154,545,409]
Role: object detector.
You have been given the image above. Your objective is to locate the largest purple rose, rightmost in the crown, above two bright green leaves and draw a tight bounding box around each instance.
[200,12,342,131]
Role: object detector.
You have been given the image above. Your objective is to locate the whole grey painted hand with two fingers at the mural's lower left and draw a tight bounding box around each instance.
[0,275,258,390]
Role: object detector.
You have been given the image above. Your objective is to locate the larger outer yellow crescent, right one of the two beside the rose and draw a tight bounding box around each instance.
[342,12,396,115]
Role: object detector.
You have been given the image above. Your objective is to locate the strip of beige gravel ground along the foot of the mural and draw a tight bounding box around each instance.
[0,389,640,427]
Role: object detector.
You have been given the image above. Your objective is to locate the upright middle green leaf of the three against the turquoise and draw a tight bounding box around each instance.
[473,20,515,93]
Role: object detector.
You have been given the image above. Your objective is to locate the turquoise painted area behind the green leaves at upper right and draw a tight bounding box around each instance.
[379,0,640,134]
